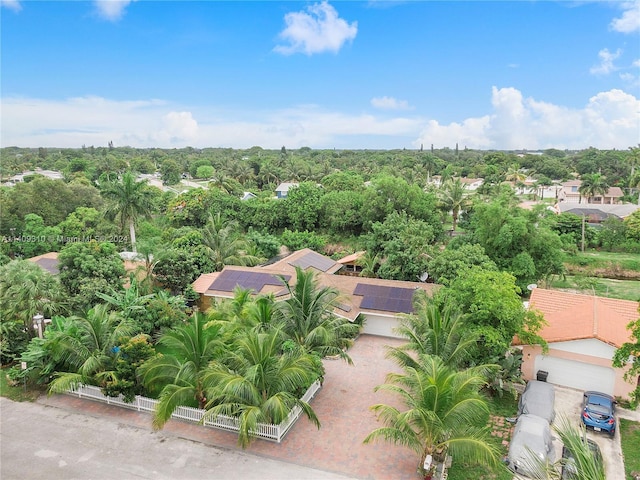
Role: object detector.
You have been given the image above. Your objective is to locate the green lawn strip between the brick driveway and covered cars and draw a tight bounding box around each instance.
[448,394,518,480]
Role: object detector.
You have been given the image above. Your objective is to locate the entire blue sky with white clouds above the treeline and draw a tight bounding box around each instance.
[0,0,640,149]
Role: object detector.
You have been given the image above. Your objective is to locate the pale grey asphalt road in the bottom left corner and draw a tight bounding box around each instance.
[0,398,358,480]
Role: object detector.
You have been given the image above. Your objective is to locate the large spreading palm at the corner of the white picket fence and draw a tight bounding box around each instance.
[203,329,320,448]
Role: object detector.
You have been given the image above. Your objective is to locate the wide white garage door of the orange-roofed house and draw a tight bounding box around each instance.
[535,355,615,395]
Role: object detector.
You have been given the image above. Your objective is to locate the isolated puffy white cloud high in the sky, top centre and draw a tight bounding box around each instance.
[274,1,358,55]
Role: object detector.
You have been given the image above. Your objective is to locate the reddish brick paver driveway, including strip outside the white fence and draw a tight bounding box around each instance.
[40,335,420,480]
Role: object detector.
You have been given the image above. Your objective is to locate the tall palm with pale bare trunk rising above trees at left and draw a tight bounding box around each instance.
[101,172,153,252]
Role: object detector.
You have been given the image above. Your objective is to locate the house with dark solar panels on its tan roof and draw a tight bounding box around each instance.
[193,249,437,337]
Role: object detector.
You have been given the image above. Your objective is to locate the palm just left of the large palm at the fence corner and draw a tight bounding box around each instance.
[139,312,224,429]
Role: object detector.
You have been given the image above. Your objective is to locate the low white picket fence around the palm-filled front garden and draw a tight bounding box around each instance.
[66,381,321,443]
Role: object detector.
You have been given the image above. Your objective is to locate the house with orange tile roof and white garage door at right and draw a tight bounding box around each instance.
[514,288,640,397]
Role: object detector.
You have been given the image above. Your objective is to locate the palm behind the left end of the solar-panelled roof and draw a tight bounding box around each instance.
[202,213,260,272]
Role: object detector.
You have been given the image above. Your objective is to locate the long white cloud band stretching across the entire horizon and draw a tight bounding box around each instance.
[0,87,640,150]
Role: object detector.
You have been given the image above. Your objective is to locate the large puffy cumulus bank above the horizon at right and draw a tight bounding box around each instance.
[414,87,640,149]
